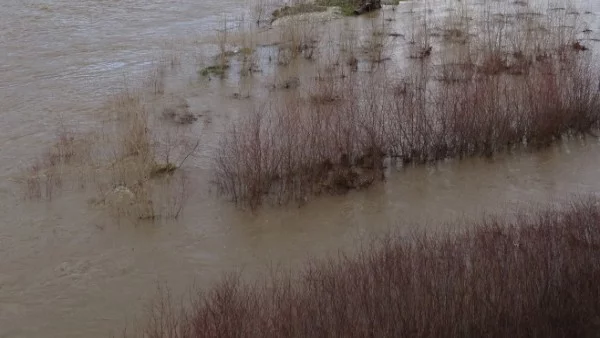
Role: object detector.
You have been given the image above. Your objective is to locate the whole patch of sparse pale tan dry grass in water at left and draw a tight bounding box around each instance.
[22,65,199,221]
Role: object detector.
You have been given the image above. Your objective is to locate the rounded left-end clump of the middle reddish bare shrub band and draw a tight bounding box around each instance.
[215,72,394,208]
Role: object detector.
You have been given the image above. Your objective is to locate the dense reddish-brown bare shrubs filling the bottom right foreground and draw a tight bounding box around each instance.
[125,200,600,338]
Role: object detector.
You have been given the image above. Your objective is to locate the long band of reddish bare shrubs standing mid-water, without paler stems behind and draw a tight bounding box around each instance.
[215,52,600,207]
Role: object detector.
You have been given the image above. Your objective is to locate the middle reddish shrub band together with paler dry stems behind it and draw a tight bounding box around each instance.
[215,3,600,208]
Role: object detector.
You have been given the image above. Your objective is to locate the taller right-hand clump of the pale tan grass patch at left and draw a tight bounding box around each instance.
[94,90,199,220]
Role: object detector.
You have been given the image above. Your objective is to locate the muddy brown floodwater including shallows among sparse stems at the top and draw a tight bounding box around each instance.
[0,0,600,337]
